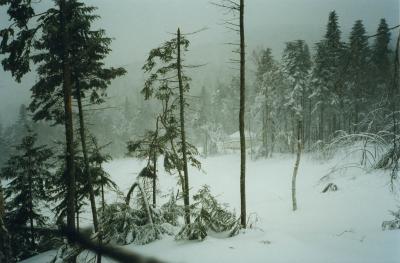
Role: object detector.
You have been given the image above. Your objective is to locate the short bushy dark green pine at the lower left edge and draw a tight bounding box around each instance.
[1,129,52,259]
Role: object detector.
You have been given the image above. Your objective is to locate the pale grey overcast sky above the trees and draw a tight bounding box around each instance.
[0,0,400,124]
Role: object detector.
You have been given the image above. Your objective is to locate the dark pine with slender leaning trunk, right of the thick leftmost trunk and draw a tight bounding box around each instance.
[66,2,126,263]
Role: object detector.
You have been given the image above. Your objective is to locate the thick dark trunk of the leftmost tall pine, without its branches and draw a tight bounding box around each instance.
[59,0,76,232]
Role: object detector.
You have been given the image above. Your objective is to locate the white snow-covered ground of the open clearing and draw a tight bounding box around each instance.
[25,154,400,263]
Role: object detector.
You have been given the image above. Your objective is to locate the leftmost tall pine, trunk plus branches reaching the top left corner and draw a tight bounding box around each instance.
[0,0,76,229]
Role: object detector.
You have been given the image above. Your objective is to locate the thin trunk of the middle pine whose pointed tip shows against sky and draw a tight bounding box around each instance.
[177,28,190,224]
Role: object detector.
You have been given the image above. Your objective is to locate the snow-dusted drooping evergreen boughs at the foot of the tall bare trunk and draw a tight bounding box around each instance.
[175,185,240,240]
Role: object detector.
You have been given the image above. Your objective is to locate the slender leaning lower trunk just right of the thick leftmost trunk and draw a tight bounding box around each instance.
[75,84,101,263]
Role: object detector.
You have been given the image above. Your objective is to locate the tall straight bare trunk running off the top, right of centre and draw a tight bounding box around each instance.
[239,0,246,228]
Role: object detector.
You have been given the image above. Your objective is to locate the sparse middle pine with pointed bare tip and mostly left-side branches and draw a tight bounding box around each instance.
[142,29,200,224]
